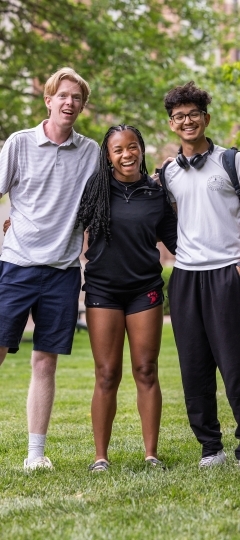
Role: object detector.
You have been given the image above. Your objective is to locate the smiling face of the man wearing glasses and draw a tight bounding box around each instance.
[169,103,210,145]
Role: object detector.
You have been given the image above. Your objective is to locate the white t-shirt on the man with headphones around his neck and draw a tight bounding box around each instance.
[165,145,240,270]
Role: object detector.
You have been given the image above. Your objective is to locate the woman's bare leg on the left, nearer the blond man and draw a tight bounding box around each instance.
[86,308,125,461]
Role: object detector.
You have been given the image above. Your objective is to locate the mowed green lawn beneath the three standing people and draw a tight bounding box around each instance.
[0,324,240,540]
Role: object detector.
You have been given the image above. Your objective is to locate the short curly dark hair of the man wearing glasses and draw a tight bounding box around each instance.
[164,81,212,116]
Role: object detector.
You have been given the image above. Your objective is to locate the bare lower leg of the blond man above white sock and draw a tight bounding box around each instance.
[27,351,57,435]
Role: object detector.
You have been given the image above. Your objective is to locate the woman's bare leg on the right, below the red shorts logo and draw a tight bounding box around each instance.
[126,306,163,457]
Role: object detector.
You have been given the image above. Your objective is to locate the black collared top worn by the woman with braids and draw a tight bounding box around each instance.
[83,175,177,293]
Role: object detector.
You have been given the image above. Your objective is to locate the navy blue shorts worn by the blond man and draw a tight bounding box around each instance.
[0,261,81,354]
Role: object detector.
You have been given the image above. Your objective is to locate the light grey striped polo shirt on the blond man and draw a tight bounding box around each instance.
[0,120,99,269]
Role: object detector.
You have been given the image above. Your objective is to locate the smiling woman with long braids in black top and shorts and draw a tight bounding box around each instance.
[75,125,176,471]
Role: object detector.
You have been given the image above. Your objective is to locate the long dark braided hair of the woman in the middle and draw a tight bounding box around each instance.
[75,124,148,243]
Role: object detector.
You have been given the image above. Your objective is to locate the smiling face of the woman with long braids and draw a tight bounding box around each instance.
[107,129,143,182]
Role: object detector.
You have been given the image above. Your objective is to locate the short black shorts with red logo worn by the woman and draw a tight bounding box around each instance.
[83,285,164,315]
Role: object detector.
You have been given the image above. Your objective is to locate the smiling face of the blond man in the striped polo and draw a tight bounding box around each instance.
[44,79,83,129]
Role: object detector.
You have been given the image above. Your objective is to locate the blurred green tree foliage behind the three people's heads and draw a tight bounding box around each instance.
[0,0,240,148]
